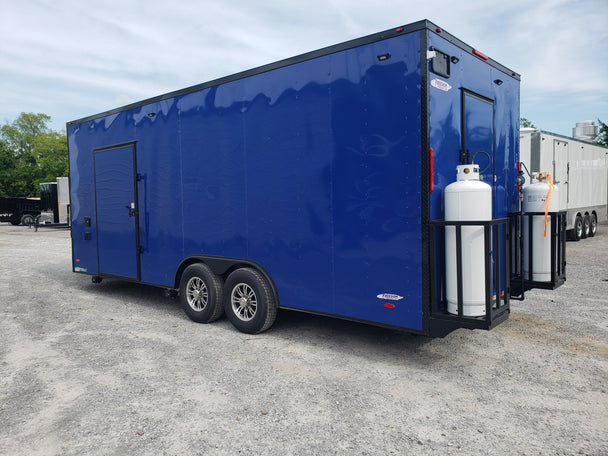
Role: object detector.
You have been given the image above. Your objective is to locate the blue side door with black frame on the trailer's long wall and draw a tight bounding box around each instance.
[94,143,140,279]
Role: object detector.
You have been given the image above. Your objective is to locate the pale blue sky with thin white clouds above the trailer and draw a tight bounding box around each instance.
[0,0,608,136]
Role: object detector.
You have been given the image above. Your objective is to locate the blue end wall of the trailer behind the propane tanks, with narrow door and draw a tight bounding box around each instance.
[428,33,519,220]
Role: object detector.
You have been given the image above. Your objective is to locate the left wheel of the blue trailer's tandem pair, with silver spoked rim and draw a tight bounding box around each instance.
[179,263,224,323]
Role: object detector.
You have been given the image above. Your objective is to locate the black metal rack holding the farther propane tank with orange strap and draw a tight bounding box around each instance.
[509,211,567,300]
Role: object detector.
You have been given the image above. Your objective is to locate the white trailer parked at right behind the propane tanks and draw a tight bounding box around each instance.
[519,122,608,241]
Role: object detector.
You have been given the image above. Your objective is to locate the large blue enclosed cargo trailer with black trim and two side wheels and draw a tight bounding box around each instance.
[67,21,540,336]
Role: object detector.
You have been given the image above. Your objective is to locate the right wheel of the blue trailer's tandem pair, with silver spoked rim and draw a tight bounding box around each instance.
[224,268,278,334]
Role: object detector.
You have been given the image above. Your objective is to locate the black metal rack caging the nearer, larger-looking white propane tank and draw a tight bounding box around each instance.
[430,218,510,337]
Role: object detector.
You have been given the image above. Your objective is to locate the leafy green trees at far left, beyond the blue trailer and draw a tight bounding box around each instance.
[0,112,68,196]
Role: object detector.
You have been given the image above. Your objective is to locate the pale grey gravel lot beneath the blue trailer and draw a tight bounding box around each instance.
[0,224,608,456]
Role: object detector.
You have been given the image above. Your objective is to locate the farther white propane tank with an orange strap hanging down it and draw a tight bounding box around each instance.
[522,173,559,282]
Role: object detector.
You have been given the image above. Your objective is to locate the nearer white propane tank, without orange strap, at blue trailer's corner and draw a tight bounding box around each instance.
[444,164,492,317]
